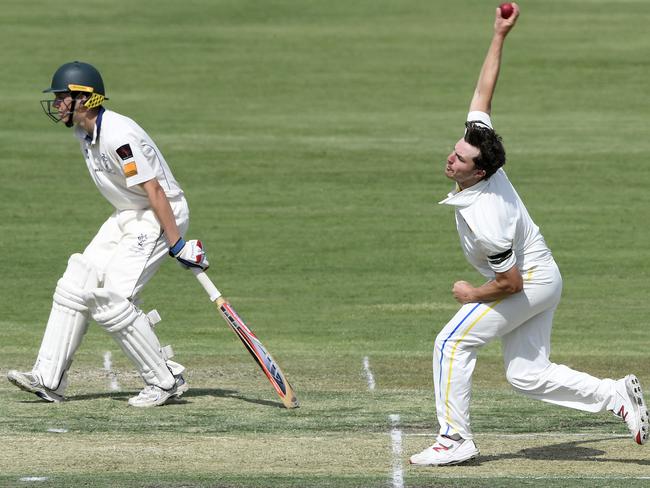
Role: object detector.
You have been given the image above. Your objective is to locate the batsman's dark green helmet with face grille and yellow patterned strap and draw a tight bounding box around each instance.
[41,61,108,127]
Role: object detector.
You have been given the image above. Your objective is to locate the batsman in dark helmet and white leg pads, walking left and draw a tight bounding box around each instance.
[7,61,209,407]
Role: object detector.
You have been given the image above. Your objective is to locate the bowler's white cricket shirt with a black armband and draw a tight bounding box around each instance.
[440,112,553,279]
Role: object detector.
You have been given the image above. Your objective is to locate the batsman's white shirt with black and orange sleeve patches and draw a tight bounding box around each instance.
[74,107,183,210]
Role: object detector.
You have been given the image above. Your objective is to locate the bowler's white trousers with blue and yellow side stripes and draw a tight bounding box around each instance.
[433,262,615,439]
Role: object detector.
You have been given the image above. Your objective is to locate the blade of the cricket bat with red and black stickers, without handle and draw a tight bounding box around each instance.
[215,298,298,408]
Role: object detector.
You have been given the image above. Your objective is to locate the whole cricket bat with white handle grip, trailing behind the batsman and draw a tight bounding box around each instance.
[192,268,298,408]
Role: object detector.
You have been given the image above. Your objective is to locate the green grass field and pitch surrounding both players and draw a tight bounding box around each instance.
[0,0,650,488]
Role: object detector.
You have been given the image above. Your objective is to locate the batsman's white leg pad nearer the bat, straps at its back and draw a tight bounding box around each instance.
[86,288,177,390]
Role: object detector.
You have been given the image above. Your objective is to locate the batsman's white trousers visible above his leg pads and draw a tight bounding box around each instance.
[83,195,189,300]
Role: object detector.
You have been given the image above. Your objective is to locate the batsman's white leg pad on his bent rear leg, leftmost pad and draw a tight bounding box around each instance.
[32,254,98,394]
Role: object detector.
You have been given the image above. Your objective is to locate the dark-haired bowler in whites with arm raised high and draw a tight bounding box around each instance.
[410,4,648,466]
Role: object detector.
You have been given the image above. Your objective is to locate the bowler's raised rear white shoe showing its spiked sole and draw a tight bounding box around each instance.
[612,374,648,444]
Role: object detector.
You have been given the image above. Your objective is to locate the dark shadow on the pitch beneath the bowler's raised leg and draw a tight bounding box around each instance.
[476,437,650,466]
